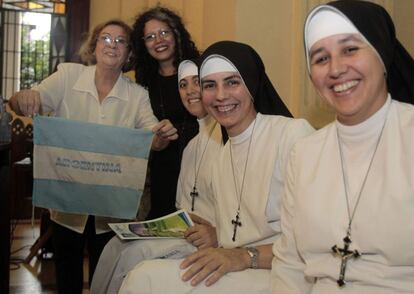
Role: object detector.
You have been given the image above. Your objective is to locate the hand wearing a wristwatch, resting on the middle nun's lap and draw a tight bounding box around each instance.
[180,248,250,286]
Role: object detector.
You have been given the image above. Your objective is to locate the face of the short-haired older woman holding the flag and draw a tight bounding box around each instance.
[95,25,130,71]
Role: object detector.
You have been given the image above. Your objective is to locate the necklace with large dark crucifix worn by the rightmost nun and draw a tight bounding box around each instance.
[331,114,387,287]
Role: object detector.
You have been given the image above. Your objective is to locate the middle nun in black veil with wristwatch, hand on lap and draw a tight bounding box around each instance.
[120,41,313,294]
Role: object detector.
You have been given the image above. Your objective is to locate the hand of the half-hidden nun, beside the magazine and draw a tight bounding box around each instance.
[184,213,218,250]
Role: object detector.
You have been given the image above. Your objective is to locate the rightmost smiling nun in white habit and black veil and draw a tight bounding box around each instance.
[272,1,414,294]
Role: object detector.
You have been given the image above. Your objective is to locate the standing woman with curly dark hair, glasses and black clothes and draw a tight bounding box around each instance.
[132,6,199,218]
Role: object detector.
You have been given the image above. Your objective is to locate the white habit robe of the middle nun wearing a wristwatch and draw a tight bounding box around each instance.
[120,113,313,294]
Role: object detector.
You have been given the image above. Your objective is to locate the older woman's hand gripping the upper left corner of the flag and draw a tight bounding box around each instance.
[9,90,41,117]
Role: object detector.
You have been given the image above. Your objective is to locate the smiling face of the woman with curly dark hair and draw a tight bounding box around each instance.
[143,19,175,62]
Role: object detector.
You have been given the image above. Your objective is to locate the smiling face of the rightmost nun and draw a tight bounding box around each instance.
[309,34,387,125]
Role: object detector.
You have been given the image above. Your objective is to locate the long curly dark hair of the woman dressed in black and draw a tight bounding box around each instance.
[131,6,199,88]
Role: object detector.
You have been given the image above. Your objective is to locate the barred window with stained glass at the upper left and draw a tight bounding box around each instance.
[0,0,67,99]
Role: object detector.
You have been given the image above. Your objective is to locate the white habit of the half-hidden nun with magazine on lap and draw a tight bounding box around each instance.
[90,116,222,294]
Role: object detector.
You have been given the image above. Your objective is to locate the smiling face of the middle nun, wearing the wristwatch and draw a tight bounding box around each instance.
[201,72,256,137]
